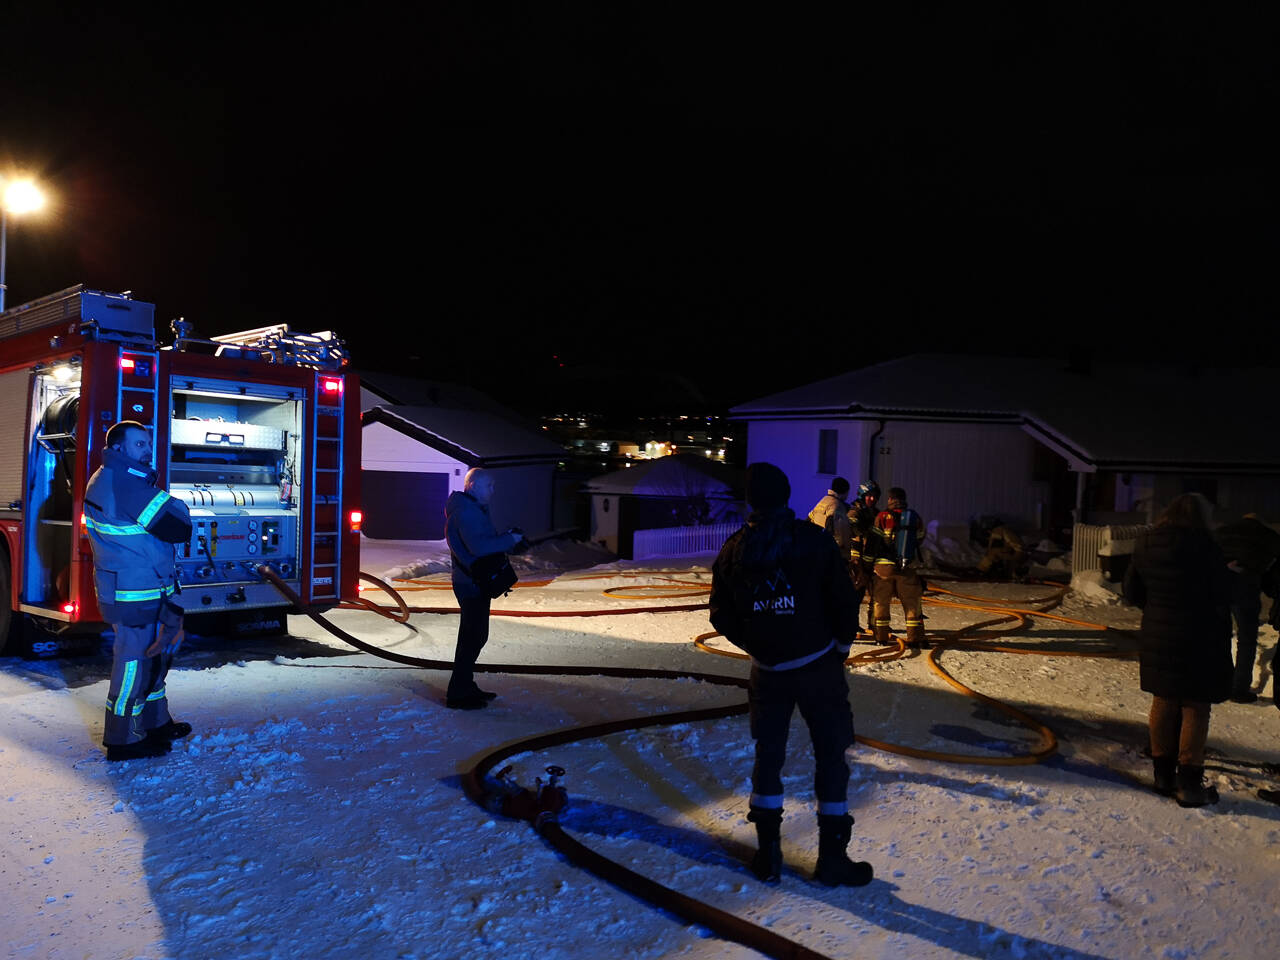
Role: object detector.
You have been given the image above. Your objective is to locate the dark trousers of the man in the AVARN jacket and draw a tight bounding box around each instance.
[748,652,854,815]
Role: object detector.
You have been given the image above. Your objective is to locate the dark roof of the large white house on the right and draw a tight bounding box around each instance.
[730,353,1280,472]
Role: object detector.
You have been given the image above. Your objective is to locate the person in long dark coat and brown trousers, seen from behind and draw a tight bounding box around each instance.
[1124,494,1233,806]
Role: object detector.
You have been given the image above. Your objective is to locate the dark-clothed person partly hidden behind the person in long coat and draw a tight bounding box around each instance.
[1213,513,1280,705]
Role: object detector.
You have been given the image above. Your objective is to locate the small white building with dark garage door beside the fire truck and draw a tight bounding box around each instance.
[360,372,564,540]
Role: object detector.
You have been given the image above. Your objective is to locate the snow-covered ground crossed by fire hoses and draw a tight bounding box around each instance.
[0,541,1280,960]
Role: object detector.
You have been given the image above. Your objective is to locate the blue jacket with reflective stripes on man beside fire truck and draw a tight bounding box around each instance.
[84,449,191,626]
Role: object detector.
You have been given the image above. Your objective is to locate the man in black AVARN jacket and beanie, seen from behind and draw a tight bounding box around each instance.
[710,463,873,886]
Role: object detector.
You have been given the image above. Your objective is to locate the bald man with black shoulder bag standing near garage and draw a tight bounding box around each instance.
[444,467,524,710]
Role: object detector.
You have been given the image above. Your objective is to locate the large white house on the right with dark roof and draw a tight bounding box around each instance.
[730,355,1280,539]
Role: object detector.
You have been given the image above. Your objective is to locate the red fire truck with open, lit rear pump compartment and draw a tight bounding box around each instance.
[0,287,361,655]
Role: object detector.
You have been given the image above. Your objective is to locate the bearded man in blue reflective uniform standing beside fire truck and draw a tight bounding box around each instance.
[84,420,191,760]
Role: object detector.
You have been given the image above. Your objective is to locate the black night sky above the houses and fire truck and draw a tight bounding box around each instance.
[0,4,1280,412]
